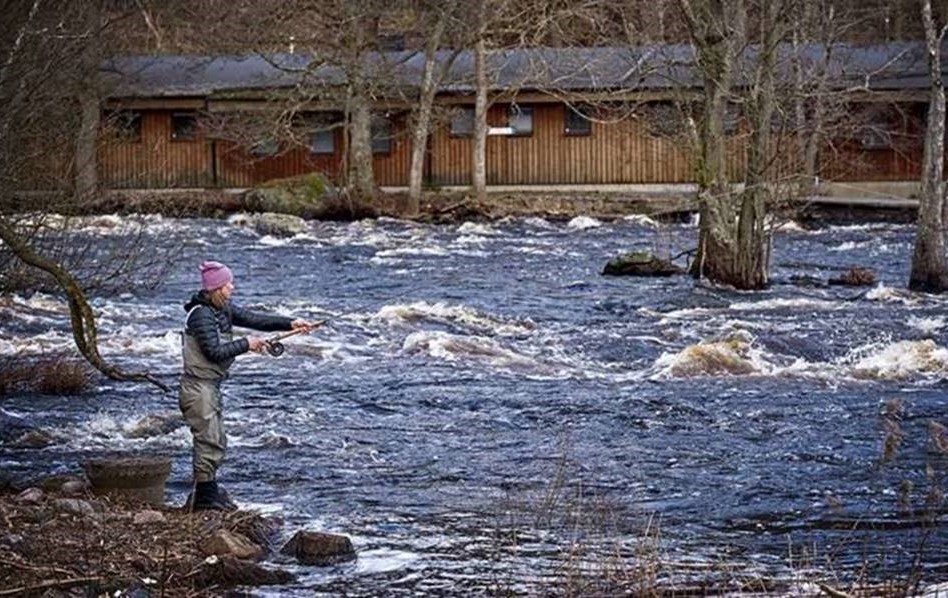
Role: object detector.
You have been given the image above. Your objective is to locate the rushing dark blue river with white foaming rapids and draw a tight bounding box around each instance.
[0,217,948,596]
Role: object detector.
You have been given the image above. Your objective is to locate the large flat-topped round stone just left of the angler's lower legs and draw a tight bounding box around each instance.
[83,457,171,505]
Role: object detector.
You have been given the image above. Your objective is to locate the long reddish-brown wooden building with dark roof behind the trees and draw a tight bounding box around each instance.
[98,44,948,188]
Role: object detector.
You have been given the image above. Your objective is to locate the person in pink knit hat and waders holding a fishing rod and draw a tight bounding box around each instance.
[178,262,321,511]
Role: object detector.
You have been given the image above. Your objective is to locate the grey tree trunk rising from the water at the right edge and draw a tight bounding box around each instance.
[908,0,948,293]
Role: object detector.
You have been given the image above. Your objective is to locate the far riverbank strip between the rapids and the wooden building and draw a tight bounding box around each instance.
[22,188,918,227]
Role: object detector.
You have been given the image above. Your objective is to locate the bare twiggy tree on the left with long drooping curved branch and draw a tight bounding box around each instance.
[0,0,167,389]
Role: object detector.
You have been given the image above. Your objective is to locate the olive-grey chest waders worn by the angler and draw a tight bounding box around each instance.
[178,322,232,483]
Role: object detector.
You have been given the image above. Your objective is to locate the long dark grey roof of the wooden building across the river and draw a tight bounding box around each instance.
[102,42,948,97]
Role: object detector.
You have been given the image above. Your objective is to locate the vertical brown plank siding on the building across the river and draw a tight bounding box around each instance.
[99,102,923,189]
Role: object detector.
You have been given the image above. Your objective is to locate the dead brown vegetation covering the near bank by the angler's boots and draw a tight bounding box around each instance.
[0,494,294,597]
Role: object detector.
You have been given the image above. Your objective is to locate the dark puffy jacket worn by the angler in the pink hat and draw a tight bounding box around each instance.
[184,291,293,368]
